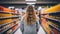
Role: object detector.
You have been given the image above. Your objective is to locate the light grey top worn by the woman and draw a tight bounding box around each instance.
[20,20,39,34]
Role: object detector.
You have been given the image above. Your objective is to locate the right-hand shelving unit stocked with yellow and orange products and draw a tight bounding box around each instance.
[41,4,60,34]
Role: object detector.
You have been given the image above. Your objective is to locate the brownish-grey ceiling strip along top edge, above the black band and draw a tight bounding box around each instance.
[0,0,60,4]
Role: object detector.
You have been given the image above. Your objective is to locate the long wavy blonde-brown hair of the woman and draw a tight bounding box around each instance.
[24,5,37,25]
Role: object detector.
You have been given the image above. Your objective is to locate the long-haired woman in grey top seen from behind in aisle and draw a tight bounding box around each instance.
[20,5,39,34]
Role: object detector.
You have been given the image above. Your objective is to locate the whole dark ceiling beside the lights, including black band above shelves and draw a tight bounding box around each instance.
[0,0,60,8]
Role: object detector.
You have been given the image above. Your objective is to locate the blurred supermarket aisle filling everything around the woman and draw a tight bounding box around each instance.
[0,0,60,34]
